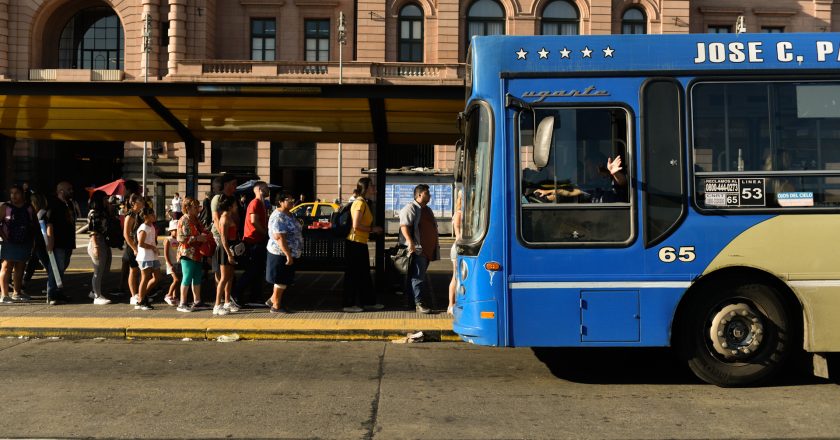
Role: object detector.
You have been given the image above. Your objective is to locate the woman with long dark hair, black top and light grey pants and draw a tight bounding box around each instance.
[88,190,112,305]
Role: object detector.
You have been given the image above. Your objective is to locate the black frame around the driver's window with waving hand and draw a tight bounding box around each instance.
[511,101,639,249]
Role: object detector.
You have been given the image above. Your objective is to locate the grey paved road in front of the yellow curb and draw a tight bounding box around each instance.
[0,339,840,439]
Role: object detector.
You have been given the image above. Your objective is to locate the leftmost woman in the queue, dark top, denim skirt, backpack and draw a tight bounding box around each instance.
[0,185,35,304]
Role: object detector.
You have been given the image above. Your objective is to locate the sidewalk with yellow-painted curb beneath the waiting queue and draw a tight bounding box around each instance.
[0,234,459,341]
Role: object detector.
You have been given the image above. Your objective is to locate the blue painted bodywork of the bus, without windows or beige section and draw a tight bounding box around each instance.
[454,34,840,347]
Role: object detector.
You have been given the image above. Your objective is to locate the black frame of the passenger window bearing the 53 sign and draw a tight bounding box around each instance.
[685,74,840,216]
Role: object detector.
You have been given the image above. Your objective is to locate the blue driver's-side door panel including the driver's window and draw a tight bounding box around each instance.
[507,78,645,346]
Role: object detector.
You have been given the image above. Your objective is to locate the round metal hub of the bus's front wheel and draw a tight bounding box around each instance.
[709,303,764,360]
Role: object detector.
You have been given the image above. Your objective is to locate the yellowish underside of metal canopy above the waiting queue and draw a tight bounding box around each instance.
[0,82,464,144]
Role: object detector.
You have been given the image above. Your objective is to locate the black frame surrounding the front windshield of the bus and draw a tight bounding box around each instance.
[456,98,496,256]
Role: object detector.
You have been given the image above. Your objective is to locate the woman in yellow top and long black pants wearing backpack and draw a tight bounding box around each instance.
[343,177,385,313]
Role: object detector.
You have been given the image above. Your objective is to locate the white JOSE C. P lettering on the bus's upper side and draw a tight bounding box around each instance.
[694,41,840,64]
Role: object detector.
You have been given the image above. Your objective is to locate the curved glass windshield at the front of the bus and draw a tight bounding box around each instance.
[461,105,492,243]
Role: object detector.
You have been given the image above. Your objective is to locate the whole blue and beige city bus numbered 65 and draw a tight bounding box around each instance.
[454,33,840,386]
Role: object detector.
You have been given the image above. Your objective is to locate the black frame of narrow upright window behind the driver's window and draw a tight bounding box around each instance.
[639,76,694,249]
